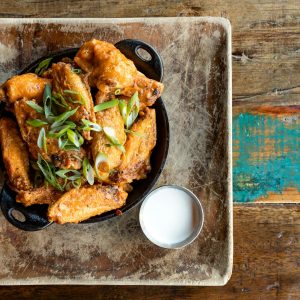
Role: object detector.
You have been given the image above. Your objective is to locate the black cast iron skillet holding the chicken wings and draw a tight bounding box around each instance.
[0,39,169,231]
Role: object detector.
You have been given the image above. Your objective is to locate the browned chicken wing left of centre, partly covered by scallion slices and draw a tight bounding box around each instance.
[15,99,85,170]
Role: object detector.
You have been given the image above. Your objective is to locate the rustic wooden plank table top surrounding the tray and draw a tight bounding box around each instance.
[0,0,300,299]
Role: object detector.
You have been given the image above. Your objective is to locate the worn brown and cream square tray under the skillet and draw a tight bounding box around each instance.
[0,17,233,285]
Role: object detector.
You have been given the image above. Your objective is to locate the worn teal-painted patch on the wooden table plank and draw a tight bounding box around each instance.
[233,113,300,202]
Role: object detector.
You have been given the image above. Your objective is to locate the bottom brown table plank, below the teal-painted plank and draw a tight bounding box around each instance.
[0,204,300,300]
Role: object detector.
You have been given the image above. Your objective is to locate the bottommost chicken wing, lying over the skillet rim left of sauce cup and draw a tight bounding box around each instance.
[48,185,128,224]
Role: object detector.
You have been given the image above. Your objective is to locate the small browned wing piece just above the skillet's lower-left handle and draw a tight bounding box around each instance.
[16,185,63,206]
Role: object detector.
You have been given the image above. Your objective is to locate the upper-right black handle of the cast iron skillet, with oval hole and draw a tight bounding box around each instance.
[115,39,164,81]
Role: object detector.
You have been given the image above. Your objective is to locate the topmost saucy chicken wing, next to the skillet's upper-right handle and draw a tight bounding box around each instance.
[74,39,164,106]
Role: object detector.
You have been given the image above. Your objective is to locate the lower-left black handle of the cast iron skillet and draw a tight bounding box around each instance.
[0,185,52,231]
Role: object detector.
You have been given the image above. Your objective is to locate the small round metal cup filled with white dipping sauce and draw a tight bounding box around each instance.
[140,186,202,248]
